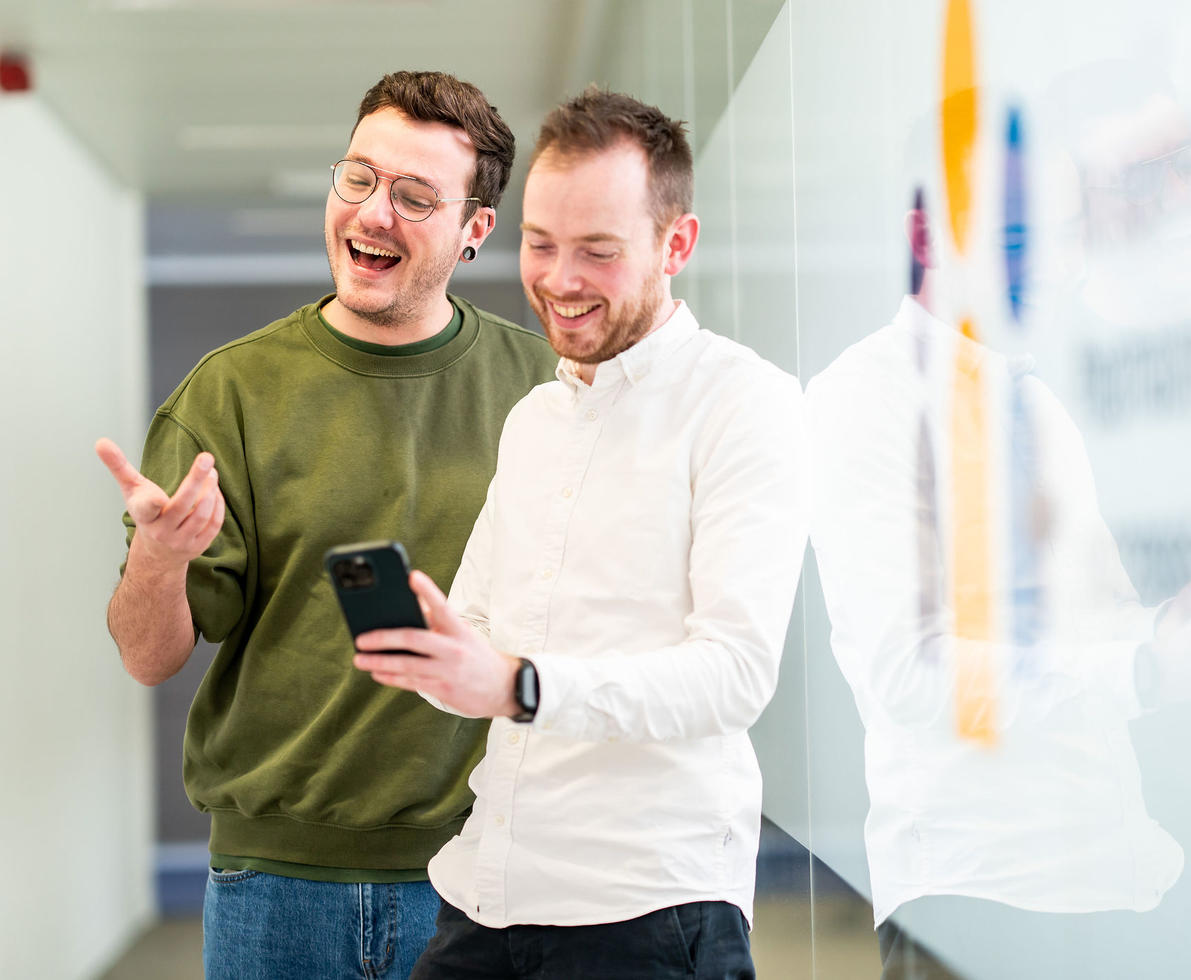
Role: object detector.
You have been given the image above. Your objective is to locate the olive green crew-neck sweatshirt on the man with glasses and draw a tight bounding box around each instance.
[125,297,557,880]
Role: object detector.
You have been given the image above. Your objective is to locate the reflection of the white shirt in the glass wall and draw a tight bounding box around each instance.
[806,298,1183,924]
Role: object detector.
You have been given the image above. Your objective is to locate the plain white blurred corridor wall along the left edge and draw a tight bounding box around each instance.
[0,95,155,976]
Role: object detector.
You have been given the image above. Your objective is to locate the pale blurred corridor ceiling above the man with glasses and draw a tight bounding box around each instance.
[0,0,601,198]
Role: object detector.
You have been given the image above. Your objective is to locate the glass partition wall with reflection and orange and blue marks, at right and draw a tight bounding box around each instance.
[605,0,1191,978]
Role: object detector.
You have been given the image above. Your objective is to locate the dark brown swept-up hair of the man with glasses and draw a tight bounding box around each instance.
[351,71,516,224]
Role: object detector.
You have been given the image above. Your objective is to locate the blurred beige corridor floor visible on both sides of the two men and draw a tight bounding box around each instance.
[98,894,880,980]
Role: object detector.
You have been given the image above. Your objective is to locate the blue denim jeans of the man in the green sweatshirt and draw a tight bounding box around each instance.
[202,870,441,980]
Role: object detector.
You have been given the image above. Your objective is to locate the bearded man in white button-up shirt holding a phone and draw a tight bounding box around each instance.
[347,90,805,979]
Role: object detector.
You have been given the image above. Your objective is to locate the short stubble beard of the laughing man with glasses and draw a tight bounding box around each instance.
[326,230,463,326]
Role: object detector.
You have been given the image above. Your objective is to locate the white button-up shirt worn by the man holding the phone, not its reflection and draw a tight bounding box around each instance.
[430,305,805,928]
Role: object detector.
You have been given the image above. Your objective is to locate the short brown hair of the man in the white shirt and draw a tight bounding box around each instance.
[530,86,694,235]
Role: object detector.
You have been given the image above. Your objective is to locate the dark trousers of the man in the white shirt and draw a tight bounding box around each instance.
[410,901,756,980]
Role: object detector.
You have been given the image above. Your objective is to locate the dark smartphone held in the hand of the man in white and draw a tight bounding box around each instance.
[323,541,426,656]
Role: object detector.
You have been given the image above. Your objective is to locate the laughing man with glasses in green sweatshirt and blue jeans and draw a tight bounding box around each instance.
[96,71,557,980]
